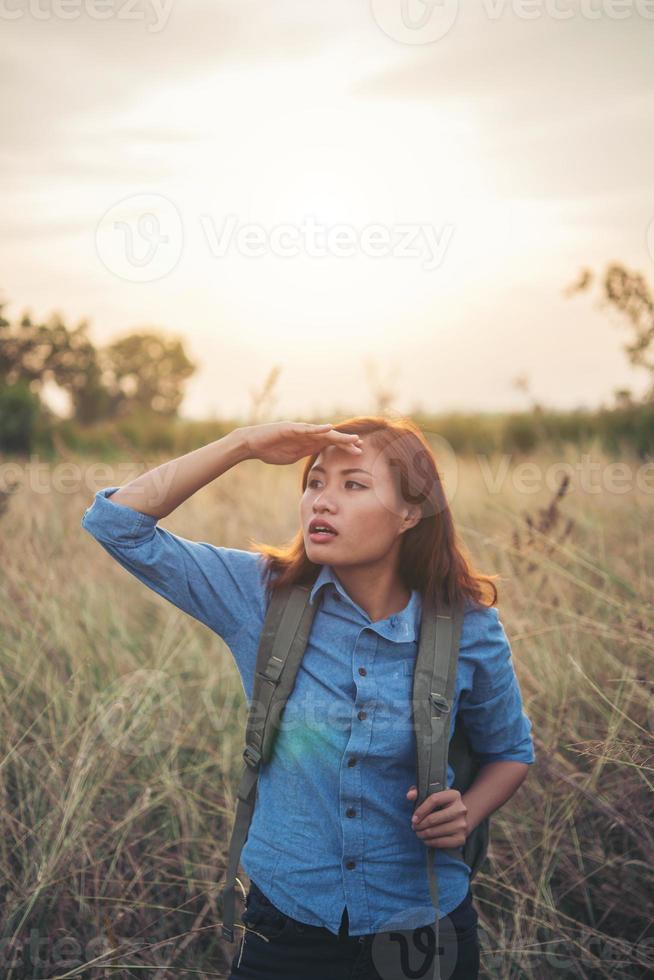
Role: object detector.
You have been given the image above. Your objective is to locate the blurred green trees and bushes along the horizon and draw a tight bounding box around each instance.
[0,262,654,458]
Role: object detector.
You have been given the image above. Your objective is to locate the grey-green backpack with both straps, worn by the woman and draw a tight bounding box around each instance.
[222,585,490,960]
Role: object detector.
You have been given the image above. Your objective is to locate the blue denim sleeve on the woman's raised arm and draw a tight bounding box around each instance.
[81,487,265,666]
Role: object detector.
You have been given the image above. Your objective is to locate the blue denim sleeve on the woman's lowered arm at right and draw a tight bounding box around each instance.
[458,606,536,764]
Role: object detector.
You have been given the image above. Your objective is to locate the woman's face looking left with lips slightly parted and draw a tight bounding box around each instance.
[300,436,416,565]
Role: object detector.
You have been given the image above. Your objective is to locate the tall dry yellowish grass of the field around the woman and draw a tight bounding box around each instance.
[0,438,654,980]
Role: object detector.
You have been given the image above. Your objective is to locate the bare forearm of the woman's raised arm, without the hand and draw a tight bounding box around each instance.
[110,426,250,520]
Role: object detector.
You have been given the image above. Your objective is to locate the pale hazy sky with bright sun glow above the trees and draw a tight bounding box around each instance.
[0,0,654,421]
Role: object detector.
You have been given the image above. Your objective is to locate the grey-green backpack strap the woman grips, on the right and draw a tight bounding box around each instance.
[412,595,463,946]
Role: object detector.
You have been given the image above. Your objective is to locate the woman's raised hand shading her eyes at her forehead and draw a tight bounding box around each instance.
[245,422,363,466]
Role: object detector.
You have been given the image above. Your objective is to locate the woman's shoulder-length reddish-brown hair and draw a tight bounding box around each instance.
[249,415,497,606]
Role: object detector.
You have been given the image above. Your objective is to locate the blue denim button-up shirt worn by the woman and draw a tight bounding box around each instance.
[82,487,536,935]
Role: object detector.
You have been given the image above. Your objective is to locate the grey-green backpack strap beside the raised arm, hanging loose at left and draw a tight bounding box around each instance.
[222,585,317,943]
